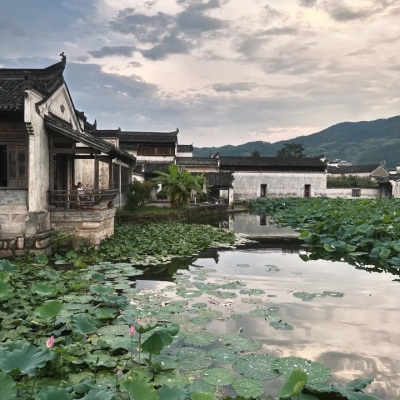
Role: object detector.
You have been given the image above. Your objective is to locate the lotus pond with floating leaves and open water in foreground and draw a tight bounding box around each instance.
[0,206,400,400]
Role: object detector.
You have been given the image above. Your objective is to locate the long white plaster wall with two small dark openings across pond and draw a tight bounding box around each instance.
[233,172,326,201]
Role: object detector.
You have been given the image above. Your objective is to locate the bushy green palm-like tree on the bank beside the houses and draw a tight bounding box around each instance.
[152,164,204,208]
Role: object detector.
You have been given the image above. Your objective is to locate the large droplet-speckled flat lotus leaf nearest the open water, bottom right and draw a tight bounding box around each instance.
[274,357,331,383]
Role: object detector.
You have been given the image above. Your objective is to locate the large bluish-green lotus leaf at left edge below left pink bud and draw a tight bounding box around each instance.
[0,344,56,376]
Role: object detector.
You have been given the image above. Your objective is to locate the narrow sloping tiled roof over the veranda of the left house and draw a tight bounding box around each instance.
[44,113,136,164]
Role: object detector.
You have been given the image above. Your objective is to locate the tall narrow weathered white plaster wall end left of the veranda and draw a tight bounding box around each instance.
[25,90,50,212]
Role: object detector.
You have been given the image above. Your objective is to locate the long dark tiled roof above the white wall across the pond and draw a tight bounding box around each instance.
[220,156,325,169]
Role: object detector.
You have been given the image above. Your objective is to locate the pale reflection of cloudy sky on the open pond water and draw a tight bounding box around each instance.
[139,249,400,399]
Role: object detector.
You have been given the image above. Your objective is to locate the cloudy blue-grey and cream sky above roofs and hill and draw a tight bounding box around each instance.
[0,0,400,147]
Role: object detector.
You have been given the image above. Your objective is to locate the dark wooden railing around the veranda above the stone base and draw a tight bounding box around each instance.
[48,189,119,210]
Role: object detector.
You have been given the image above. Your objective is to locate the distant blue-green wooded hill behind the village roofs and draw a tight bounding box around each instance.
[193,116,400,168]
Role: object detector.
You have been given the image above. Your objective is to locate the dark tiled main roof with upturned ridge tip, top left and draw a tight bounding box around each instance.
[0,61,65,111]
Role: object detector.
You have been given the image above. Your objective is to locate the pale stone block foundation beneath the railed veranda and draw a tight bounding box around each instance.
[50,208,115,247]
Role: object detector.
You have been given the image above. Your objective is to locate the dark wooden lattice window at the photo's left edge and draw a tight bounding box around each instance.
[0,143,27,187]
